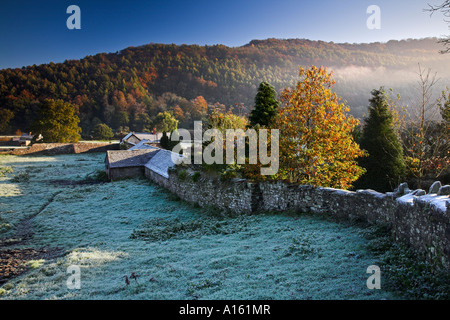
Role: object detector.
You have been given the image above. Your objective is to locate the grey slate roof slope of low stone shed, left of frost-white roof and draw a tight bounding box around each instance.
[105,148,159,168]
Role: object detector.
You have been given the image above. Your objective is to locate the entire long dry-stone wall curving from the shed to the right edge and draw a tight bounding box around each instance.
[145,167,450,268]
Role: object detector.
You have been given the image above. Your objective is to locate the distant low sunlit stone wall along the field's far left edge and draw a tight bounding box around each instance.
[8,142,119,155]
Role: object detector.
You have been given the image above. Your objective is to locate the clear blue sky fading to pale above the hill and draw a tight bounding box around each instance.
[0,0,450,69]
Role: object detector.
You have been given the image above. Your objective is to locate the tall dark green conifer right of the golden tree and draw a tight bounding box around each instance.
[355,88,405,192]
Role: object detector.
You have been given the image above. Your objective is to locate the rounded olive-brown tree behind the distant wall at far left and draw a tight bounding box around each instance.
[31,99,81,143]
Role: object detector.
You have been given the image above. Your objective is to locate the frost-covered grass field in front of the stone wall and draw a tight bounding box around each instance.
[0,154,393,299]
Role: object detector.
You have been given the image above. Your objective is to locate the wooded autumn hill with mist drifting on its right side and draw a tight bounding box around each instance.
[0,38,450,136]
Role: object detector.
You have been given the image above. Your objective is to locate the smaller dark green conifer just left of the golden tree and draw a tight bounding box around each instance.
[249,82,280,127]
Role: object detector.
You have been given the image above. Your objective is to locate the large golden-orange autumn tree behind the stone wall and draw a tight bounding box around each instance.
[276,66,364,188]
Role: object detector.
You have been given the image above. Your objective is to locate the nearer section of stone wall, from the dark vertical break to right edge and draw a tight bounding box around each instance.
[258,182,450,267]
